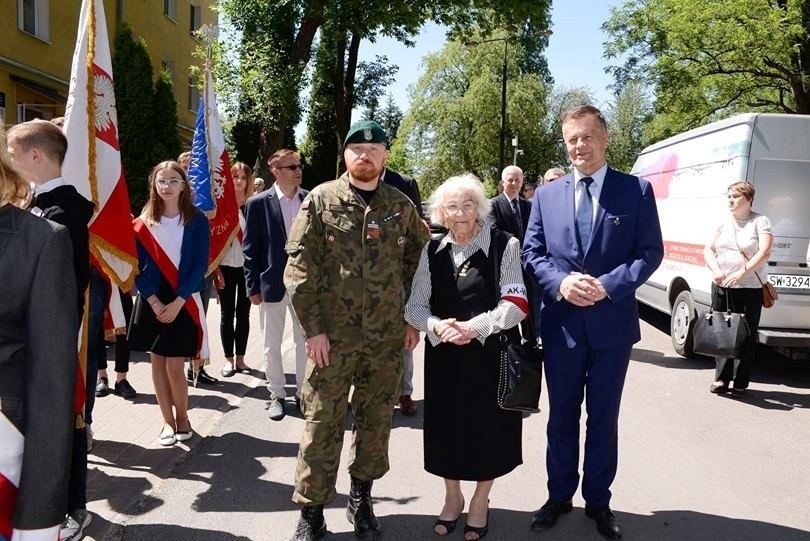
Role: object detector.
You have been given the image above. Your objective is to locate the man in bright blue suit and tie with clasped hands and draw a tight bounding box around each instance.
[523,105,664,539]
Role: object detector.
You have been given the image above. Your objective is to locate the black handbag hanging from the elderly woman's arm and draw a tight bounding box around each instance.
[490,227,543,413]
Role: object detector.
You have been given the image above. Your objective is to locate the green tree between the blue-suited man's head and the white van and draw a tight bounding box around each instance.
[605,81,652,171]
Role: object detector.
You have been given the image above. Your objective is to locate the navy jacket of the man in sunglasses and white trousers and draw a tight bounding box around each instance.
[242,187,309,302]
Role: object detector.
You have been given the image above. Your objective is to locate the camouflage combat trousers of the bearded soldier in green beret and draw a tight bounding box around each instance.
[292,340,402,505]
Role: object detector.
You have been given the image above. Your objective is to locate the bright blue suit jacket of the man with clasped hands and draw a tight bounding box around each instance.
[523,168,664,349]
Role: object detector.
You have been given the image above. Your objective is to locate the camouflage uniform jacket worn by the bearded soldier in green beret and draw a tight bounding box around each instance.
[284,174,429,342]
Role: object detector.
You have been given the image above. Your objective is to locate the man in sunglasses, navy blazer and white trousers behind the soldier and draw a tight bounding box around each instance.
[242,149,308,421]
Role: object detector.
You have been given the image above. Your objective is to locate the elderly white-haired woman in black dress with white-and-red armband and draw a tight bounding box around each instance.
[405,174,528,541]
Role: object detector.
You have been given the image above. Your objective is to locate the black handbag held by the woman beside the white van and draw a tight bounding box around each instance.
[693,286,751,358]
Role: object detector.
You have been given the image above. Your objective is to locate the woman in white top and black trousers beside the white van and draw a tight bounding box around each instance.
[703,182,773,398]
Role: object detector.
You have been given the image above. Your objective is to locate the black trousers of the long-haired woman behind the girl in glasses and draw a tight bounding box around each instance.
[219,265,250,357]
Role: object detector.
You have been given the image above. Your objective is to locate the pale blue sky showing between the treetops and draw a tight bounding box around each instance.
[355,0,623,114]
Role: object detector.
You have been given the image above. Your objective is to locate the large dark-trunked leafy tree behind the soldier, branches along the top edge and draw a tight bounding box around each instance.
[219,0,550,177]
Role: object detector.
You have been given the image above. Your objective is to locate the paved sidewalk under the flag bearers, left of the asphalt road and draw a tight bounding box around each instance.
[85,299,274,541]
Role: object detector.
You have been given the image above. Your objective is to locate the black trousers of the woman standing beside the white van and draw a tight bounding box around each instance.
[712,284,762,389]
